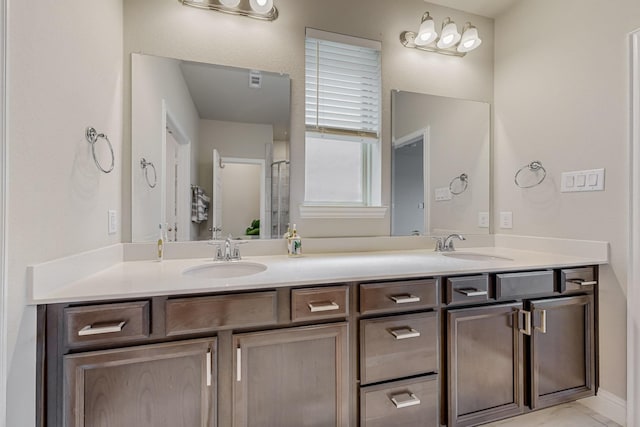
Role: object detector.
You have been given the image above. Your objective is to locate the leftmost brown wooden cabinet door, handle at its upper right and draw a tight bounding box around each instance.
[64,338,216,427]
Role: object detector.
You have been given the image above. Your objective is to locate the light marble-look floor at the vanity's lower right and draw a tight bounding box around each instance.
[484,402,621,427]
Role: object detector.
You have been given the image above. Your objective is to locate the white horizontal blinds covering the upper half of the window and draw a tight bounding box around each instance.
[305,30,380,139]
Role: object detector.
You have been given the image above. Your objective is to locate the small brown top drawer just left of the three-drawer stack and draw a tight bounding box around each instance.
[291,286,349,322]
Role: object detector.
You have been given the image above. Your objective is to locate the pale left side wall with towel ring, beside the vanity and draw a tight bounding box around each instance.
[6,0,123,427]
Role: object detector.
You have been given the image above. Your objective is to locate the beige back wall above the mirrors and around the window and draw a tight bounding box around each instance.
[123,0,493,240]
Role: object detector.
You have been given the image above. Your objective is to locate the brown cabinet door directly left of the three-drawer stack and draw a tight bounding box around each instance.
[233,324,350,427]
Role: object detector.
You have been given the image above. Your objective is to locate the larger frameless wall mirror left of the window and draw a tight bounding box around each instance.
[131,54,291,242]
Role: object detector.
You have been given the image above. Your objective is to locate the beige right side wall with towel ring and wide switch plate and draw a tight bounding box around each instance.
[493,0,640,398]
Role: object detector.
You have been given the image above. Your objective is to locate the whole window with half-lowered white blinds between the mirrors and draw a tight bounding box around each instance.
[305,29,381,206]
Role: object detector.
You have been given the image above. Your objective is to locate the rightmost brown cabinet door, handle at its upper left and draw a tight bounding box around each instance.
[530,295,595,409]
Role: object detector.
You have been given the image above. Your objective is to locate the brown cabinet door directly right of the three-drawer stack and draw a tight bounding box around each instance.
[447,303,528,427]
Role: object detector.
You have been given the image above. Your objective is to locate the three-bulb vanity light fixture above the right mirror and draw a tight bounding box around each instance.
[400,12,482,56]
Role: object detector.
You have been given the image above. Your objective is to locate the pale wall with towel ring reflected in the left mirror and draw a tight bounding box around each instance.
[131,55,200,242]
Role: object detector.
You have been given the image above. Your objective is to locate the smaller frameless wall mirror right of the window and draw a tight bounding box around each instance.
[391,90,490,236]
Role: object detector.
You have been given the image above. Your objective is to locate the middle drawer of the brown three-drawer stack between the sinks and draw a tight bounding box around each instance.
[360,312,438,384]
